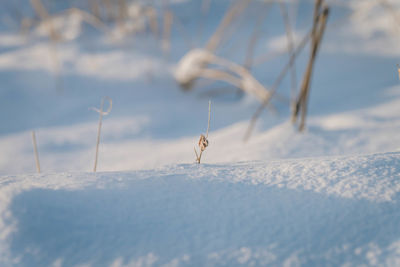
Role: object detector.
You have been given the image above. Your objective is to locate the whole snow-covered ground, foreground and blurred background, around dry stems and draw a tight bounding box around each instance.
[0,1,400,266]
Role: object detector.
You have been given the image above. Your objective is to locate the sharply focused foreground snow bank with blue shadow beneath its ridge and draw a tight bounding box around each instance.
[0,153,400,266]
